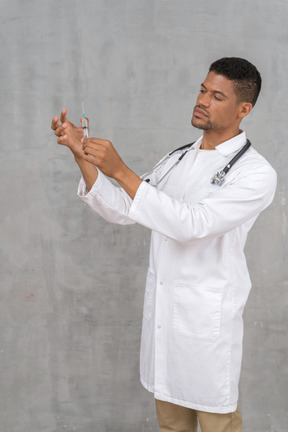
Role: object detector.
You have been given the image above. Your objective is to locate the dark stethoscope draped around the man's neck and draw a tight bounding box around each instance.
[142,139,251,187]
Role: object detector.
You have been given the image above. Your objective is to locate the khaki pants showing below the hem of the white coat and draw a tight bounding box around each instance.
[155,399,242,432]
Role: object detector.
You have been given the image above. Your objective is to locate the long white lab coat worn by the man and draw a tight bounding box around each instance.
[78,132,276,413]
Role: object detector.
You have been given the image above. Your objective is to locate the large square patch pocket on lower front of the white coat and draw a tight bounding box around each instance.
[173,283,222,342]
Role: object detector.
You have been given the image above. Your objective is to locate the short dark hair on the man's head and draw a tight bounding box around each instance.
[209,57,262,106]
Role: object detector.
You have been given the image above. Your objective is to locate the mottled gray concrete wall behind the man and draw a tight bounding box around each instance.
[0,0,288,432]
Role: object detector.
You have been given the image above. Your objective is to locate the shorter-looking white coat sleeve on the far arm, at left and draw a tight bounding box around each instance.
[78,170,135,225]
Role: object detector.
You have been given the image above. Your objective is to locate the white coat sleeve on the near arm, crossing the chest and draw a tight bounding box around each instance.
[128,164,277,243]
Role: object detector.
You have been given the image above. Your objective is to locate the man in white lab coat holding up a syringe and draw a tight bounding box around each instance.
[52,57,276,432]
